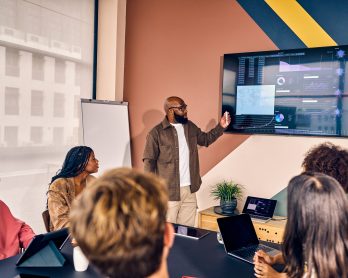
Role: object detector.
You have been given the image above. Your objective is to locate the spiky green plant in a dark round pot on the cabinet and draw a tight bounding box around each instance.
[210,180,243,214]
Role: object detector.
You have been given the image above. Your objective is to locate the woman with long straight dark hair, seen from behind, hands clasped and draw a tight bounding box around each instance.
[254,172,348,278]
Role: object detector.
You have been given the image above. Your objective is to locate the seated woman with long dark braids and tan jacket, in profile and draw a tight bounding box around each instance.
[47,146,99,231]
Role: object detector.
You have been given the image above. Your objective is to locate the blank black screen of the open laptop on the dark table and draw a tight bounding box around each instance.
[217,214,259,253]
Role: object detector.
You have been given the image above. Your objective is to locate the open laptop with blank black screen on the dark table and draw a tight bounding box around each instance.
[217,213,280,264]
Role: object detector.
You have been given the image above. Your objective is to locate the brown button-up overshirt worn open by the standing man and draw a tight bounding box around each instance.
[143,117,224,201]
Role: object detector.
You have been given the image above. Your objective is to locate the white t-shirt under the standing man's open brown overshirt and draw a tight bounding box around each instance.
[171,124,191,186]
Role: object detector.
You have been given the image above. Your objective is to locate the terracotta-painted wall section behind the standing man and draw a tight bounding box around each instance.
[124,0,276,174]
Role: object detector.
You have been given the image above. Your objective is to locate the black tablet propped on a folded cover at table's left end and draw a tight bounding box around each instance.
[16,228,69,266]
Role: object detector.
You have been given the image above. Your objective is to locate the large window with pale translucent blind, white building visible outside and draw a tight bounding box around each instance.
[0,0,95,233]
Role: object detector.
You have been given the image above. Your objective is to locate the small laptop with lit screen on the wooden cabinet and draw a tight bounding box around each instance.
[243,196,277,223]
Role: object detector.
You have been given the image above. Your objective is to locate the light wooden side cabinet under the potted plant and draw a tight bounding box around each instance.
[198,207,286,244]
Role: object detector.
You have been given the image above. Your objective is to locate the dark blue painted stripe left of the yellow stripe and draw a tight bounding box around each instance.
[237,0,306,49]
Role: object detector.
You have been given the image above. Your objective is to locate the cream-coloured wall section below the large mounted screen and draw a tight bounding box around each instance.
[197,135,348,210]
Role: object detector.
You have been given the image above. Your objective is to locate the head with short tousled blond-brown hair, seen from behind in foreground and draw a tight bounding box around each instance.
[70,168,174,277]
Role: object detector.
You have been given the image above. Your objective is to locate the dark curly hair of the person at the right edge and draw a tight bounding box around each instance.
[302,142,348,193]
